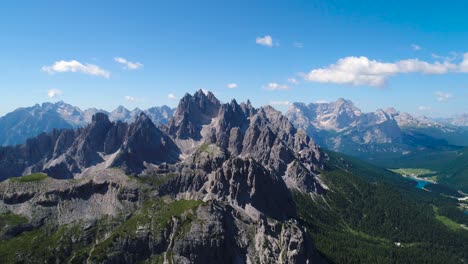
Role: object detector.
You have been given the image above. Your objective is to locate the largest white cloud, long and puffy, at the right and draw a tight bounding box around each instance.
[304,56,460,87]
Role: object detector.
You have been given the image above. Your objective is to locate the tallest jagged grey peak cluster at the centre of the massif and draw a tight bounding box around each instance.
[166,94,326,193]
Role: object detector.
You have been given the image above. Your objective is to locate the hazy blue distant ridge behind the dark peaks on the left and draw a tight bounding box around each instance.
[0,101,174,146]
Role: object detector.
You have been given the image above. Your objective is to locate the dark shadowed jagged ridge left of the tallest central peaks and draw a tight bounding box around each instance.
[0,113,179,182]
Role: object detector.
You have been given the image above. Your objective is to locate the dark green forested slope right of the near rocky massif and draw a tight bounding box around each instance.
[294,152,468,263]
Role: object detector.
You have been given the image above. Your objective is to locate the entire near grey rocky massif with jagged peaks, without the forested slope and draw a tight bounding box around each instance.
[0,91,327,263]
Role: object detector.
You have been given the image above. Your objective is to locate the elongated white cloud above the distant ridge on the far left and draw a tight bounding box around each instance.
[42,60,110,78]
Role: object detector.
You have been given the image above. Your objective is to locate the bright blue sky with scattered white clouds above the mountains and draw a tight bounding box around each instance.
[0,0,468,116]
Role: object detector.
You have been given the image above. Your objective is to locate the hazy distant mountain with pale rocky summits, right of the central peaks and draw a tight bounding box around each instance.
[286,99,463,159]
